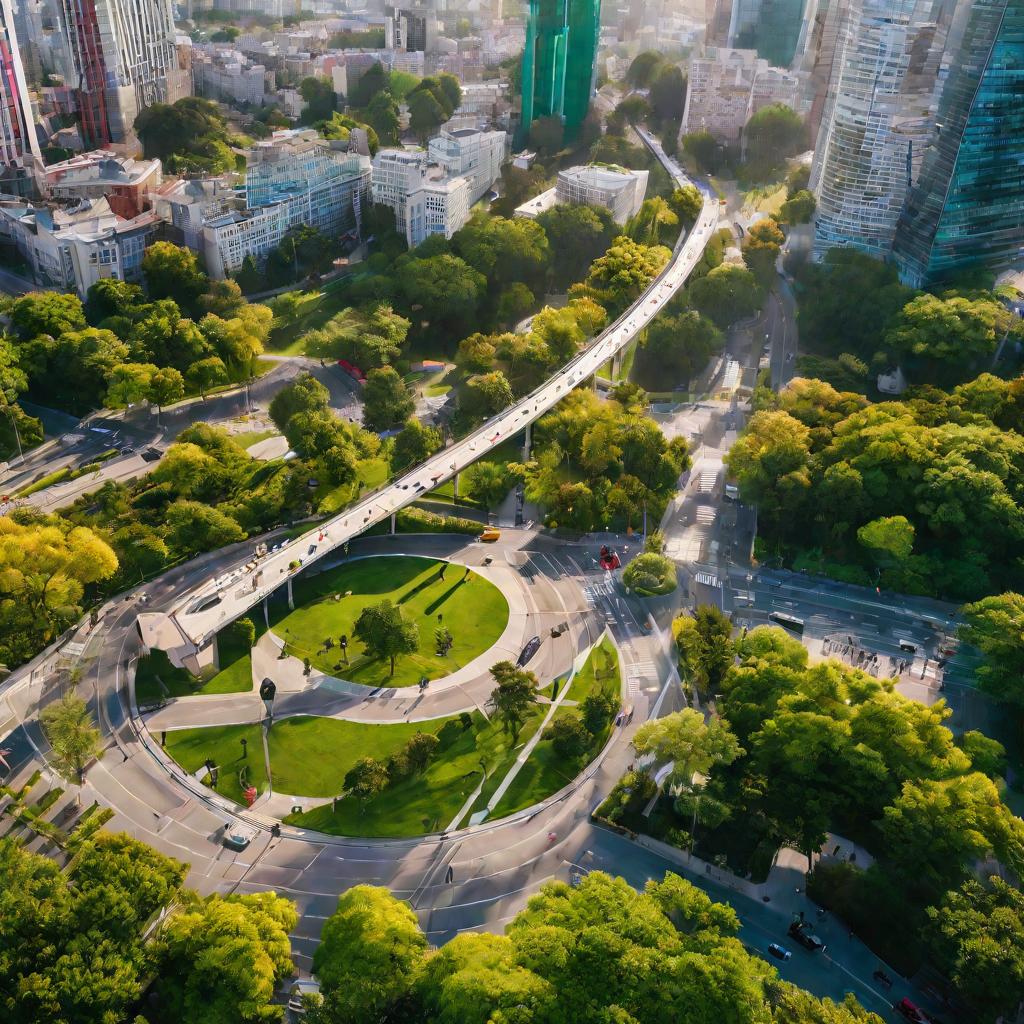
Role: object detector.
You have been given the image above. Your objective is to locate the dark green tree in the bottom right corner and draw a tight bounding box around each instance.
[928,876,1024,1020]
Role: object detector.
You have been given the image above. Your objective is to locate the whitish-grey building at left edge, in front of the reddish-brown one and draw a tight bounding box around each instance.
[0,199,160,298]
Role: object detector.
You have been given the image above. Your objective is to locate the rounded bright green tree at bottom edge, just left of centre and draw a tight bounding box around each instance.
[311,886,427,1024]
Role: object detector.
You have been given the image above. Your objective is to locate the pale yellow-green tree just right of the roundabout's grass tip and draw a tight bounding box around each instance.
[633,708,743,790]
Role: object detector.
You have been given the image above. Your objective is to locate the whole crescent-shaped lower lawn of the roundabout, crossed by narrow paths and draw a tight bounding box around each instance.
[160,638,622,838]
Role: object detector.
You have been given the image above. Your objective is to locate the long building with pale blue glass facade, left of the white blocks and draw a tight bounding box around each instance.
[203,128,371,279]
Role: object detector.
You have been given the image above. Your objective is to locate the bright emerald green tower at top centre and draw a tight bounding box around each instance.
[517,0,601,145]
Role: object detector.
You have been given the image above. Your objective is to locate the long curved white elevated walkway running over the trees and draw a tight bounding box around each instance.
[139,136,719,669]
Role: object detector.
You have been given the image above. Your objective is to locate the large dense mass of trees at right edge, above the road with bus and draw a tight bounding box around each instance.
[728,376,1024,598]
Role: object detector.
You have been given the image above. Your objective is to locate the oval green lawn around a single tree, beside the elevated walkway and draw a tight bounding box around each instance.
[271,555,509,686]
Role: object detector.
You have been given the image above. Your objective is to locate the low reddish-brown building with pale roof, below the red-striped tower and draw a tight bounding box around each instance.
[40,150,163,219]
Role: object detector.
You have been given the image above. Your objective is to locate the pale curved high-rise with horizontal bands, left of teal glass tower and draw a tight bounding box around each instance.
[811,0,952,259]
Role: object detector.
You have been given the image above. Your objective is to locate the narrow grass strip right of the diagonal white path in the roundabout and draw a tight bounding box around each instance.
[492,637,623,818]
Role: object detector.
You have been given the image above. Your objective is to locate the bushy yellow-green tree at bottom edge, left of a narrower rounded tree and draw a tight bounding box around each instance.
[157,892,299,1024]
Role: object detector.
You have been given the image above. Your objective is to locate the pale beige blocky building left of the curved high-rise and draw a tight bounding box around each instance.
[681,47,801,145]
